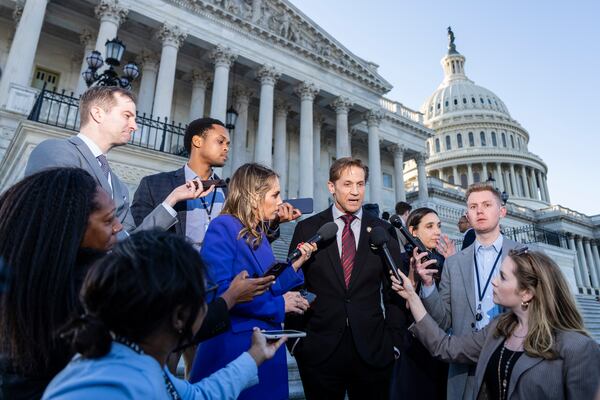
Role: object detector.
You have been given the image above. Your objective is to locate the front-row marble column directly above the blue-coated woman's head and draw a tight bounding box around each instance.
[254,65,281,167]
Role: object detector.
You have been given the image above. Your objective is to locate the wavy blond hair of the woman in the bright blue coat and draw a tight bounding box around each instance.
[221,163,278,249]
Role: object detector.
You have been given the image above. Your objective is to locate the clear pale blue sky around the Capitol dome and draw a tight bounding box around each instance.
[291,0,600,215]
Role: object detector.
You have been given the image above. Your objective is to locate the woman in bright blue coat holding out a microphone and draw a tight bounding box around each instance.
[191,164,316,399]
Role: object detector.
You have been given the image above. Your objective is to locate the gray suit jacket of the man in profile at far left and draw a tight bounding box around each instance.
[25,136,177,232]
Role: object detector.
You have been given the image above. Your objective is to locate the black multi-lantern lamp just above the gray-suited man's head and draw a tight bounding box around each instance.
[82,38,140,89]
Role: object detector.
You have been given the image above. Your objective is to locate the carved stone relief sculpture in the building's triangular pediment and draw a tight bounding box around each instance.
[167,0,392,94]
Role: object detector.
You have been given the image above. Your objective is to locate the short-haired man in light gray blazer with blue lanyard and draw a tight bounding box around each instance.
[416,183,518,400]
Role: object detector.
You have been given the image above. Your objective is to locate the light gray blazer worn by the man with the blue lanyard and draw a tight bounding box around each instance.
[423,237,519,400]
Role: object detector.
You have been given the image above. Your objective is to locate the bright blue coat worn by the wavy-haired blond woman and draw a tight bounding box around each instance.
[191,215,304,399]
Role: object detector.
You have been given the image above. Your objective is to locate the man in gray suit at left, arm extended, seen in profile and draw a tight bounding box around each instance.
[25,86,203,232]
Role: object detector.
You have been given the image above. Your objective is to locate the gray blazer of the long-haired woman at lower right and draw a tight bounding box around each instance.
[409,315,600,400]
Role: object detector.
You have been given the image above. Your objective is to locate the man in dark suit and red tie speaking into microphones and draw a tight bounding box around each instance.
[286,157,401,400]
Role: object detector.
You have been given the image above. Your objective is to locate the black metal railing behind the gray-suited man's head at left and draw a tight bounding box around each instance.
[27,87,187,157]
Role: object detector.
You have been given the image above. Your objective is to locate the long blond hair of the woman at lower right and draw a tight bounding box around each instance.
[495,250,589,359]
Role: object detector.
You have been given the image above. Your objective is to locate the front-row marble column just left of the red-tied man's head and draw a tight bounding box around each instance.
[296,82,319,197]
